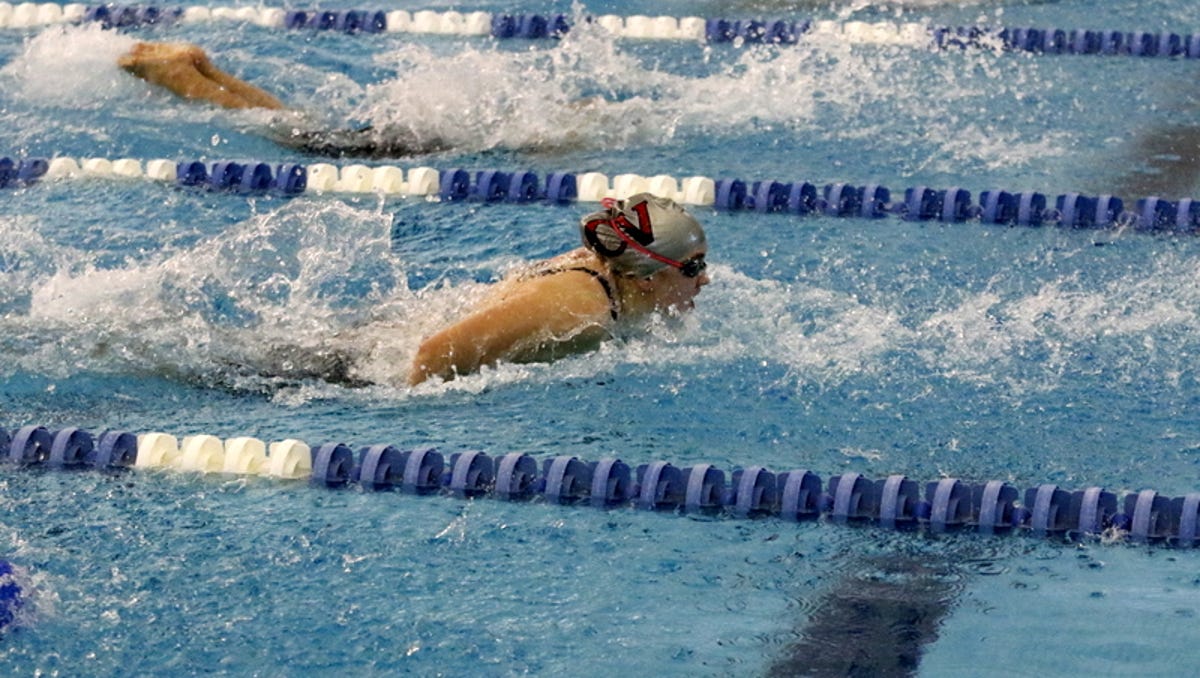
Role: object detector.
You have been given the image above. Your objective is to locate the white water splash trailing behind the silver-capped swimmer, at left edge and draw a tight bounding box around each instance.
[0,200,407,384]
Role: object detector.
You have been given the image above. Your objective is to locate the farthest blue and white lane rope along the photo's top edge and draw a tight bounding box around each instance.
[0,2,1200,59]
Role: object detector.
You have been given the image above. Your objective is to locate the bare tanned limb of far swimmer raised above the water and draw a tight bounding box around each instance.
[116,42,284,110]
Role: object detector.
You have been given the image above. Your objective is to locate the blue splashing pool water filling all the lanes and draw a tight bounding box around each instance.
[0,1,1200,676]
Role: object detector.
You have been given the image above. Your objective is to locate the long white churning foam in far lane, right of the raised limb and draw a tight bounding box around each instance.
[336,17,1075,175]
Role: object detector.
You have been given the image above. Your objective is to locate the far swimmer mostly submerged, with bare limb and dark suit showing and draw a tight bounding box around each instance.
[116,42,445,158]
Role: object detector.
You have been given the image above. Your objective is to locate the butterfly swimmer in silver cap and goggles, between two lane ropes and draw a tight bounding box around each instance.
[408,193,709,385]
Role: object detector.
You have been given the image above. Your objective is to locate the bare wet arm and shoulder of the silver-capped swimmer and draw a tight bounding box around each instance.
[408,271,610,385]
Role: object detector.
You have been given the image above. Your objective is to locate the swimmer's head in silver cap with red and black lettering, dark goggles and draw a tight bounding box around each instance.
[580,193,706,277]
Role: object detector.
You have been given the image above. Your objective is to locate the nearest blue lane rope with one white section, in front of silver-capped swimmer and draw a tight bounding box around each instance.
[0,426,1200,547]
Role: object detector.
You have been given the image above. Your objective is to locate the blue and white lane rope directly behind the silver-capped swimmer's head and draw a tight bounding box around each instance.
[9,157,1200,234]
